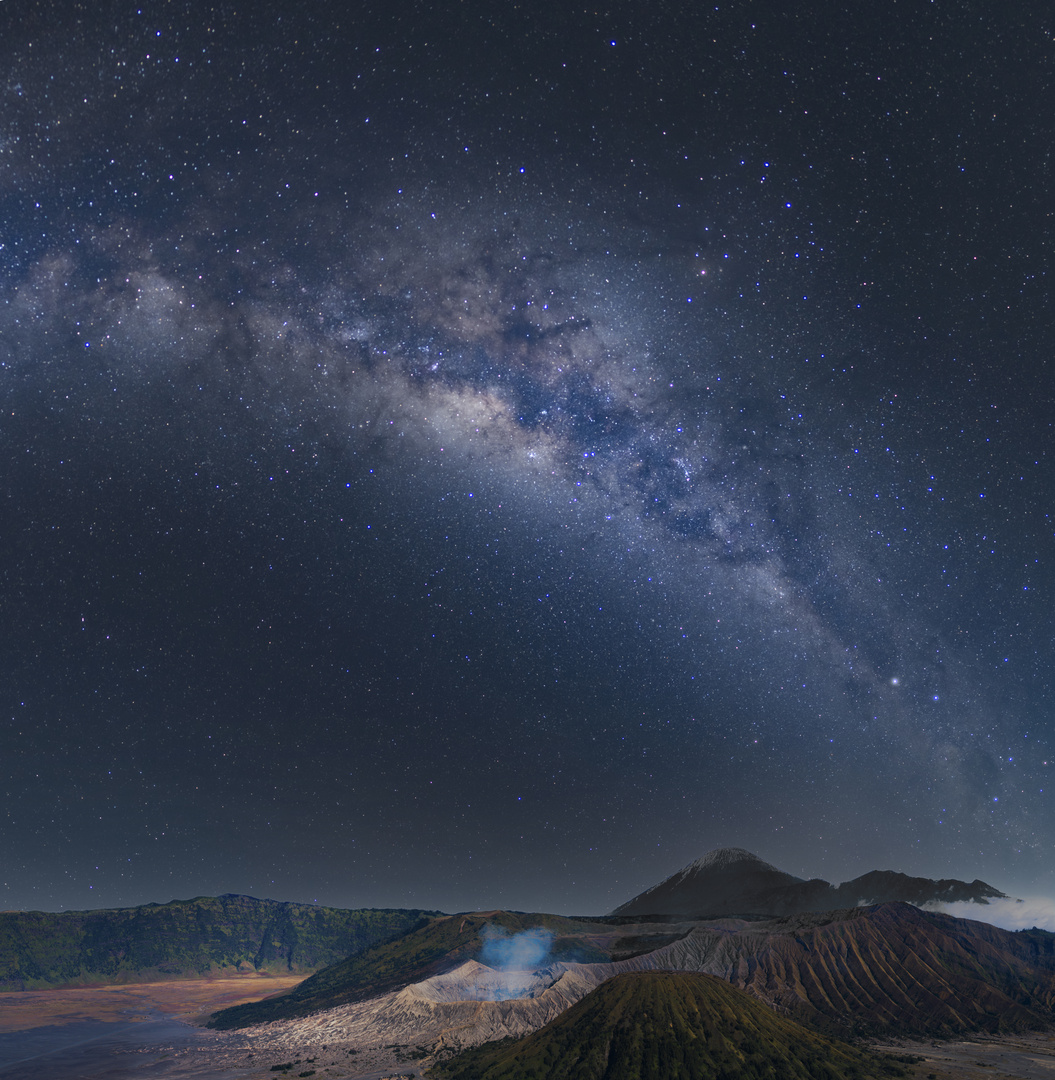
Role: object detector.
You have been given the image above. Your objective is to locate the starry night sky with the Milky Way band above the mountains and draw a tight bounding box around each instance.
[0,0,1055,914]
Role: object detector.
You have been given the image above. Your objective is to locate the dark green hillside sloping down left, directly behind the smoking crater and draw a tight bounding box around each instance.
[208,912,609,1030]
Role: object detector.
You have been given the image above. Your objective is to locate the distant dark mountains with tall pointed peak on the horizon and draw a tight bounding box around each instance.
[611,848,1009,917]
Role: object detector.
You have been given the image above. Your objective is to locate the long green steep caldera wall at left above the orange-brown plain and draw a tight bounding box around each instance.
[0,895,424,990]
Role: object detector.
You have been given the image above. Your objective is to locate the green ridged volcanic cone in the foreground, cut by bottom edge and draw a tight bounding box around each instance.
[430,971,905,1080]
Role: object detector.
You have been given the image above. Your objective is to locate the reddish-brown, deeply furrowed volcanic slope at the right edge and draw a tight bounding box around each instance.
[708,903,1055,1036]
